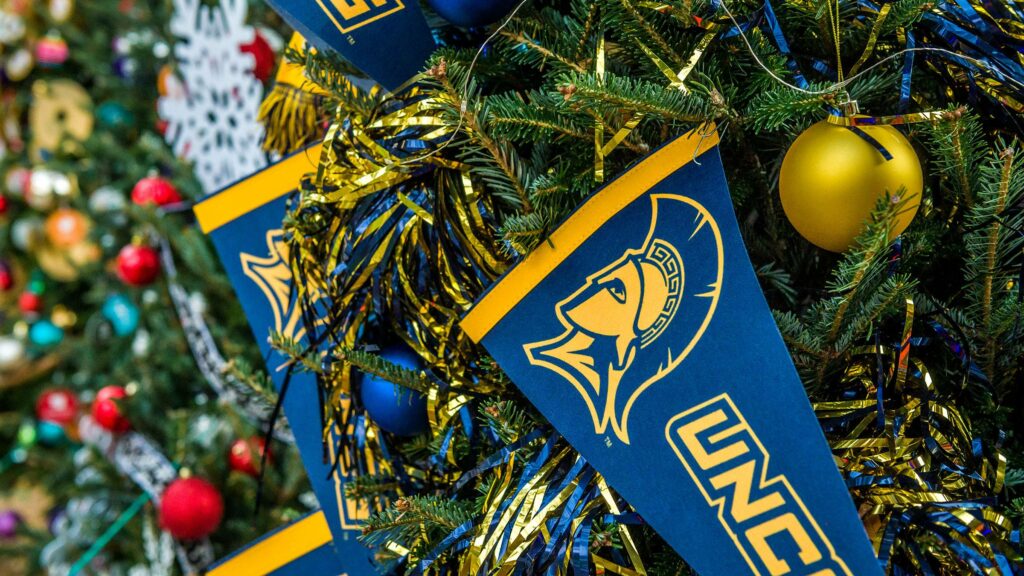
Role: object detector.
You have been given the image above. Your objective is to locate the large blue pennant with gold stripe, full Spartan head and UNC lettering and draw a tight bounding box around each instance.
[462,127,882,576]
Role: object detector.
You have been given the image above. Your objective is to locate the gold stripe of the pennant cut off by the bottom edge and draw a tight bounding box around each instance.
[207,511,331,576]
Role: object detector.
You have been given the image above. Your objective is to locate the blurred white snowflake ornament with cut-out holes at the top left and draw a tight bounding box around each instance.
[159,0,267,194]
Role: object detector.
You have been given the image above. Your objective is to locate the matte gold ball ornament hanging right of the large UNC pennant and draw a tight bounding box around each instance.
[778,121,924,252]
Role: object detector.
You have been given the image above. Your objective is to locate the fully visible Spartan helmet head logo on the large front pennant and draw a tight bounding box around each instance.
[523,194,724,444]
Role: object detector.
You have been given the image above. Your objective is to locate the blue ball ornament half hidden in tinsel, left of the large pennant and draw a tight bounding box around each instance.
[359,346,430,436]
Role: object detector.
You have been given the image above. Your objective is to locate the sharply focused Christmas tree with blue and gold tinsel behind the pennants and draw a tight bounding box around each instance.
[264,0,1024,574]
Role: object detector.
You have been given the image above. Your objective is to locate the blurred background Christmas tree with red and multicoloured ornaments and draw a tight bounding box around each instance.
[0,1,315,575]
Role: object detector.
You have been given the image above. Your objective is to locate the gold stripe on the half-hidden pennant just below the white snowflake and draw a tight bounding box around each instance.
[193,143,323,234]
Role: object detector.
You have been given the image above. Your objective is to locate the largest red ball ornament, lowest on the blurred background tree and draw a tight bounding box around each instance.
[160,478,224,540]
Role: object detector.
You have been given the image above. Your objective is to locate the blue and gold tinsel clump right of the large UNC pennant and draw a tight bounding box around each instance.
[813,300,1022,575]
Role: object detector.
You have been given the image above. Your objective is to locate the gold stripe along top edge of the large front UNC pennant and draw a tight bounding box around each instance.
[461,125,718,342]
